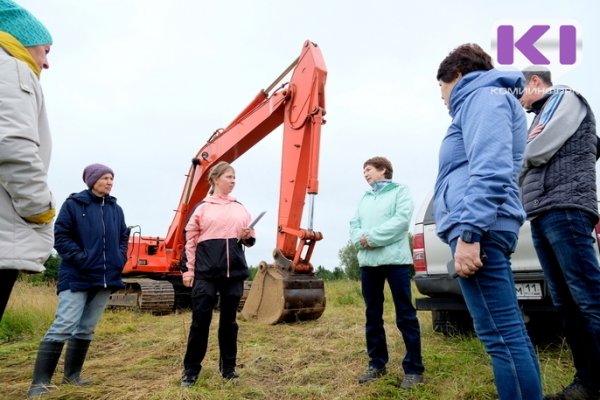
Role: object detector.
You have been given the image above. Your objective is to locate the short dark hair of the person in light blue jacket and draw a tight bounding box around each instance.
[436,43,494,83]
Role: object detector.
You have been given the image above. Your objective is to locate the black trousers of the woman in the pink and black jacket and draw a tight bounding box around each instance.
[183,278,244,375]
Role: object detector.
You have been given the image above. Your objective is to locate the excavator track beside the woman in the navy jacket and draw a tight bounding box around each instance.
[108,278,175,314]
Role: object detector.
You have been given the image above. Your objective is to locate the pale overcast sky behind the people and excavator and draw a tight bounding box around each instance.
[17,0,600,269]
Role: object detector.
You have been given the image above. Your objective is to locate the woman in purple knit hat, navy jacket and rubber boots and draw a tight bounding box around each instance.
[27,164,129,397]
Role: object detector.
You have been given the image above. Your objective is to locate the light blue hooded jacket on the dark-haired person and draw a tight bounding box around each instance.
[434,69,527,243]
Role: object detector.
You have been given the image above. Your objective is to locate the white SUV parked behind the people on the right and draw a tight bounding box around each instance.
[413,196,598,335]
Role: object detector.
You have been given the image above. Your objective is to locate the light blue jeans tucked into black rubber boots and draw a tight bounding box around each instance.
[42,289,110,343]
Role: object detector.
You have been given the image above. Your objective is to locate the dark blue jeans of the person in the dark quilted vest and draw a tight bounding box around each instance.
[531,209,600,389]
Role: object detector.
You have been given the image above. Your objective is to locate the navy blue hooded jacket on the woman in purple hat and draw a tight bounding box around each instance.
[54,190,129,293]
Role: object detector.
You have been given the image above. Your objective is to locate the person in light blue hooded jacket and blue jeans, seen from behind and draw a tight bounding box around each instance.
[434,44,542,400]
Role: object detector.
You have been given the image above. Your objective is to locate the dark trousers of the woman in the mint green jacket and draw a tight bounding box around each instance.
[360,265,425,374]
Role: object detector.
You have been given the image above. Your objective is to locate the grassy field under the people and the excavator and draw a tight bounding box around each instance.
[0,281,573,400]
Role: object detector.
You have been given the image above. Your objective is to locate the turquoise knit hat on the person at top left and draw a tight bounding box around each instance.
[0,0,52,47]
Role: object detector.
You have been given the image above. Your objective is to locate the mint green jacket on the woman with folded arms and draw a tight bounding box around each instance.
[350,182,414,267]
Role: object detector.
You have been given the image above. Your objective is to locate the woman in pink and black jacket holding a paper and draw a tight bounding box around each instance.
[181,161,256,387]
